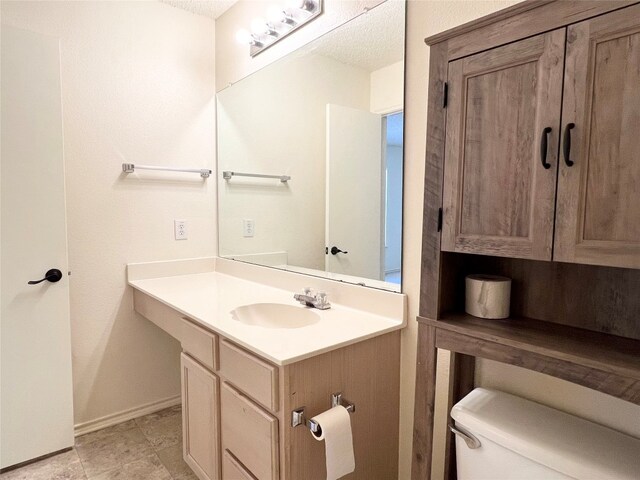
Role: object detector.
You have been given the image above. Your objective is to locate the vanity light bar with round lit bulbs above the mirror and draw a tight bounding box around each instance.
[236,0,322,57]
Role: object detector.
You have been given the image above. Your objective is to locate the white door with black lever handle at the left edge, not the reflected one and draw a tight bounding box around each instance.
[0,25,73,468]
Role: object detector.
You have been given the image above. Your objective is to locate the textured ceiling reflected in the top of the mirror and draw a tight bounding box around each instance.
[312,0,404,72]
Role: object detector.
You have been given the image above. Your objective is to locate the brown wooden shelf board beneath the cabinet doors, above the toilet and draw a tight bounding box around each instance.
[418,313,640,405]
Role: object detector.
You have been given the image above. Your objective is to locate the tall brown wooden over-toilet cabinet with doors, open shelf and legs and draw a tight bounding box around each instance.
[412,0,640,480]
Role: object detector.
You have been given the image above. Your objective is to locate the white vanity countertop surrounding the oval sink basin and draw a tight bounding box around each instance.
[129,259,406,365]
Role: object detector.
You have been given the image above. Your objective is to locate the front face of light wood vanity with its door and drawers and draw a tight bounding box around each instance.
[180,318,280,480]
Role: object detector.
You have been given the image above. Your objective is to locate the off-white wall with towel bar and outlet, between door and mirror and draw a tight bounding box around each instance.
[1,1,216,432]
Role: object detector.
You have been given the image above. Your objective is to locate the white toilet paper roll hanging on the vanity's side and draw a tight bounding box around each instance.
[311,405,356,480]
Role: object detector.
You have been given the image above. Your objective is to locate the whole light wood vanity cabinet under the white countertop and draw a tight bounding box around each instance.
[124,290,400,480]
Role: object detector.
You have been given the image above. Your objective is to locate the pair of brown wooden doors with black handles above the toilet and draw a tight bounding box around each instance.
[441,1,640,268]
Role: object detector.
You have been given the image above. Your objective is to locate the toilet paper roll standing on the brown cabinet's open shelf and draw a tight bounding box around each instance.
[464,275,511,319]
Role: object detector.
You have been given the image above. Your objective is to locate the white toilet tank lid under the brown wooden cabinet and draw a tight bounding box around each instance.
[451,388,640,480]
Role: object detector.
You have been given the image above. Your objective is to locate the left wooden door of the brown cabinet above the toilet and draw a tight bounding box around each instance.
[442,29,565,260]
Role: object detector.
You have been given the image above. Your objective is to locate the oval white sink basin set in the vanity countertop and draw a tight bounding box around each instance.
[231,303,320,328]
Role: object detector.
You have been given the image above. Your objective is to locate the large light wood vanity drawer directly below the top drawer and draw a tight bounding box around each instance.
[221,382,279,480]
